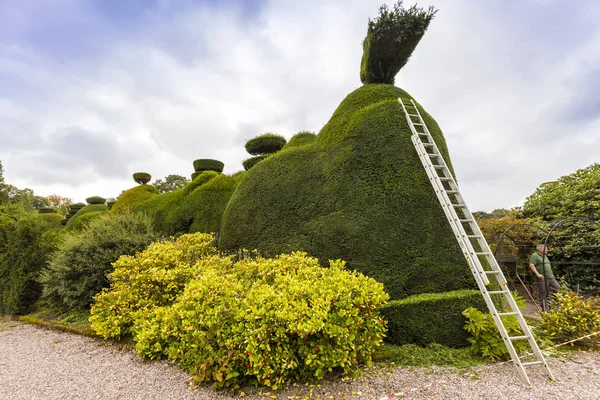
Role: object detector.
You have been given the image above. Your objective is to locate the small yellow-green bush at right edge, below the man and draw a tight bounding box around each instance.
[540,290,600,346]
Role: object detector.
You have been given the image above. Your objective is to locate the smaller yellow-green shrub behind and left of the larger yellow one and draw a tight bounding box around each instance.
[90,233,221,338]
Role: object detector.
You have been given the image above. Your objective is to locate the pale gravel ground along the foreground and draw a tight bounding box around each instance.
[0,319,600,400]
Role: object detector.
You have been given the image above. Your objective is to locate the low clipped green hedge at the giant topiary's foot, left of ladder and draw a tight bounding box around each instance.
[378,290,487,347]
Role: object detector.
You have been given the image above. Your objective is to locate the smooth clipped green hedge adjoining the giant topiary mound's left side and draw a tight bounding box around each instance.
[134,171,239,236]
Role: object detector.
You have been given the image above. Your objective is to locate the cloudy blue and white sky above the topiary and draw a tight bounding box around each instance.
[0,0,600,211]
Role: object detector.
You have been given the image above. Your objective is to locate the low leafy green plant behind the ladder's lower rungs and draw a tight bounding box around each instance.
[463,307,532,361]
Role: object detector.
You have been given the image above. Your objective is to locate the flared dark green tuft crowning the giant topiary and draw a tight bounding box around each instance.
[360,0,437,85]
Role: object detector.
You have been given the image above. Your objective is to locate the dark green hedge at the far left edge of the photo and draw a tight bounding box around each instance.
[0,207,57,314]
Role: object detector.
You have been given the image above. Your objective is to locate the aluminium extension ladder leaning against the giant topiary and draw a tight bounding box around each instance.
[398,98,554,385]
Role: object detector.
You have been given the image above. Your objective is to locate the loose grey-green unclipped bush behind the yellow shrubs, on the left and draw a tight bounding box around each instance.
[40,212,158,310]
